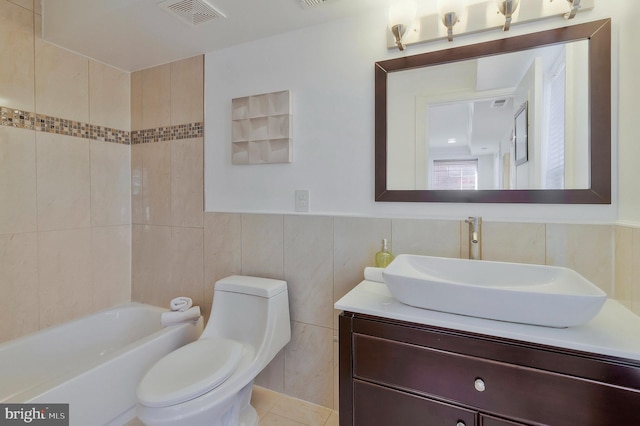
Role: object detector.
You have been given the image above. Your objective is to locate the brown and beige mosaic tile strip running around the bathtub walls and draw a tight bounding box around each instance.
[0,106,204,145]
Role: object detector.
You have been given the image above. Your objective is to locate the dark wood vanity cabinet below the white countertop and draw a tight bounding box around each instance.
[339,312,640,426]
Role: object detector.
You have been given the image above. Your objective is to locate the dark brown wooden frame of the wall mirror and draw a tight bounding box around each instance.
[375,19,611,204]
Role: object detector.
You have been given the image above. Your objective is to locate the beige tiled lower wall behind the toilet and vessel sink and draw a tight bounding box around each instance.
[199,213,640,408]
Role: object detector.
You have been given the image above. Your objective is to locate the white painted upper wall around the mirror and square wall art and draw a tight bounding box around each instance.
[205,0,640,223]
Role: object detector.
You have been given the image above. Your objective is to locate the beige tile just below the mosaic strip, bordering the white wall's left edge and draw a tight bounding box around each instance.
[171,138,204,228]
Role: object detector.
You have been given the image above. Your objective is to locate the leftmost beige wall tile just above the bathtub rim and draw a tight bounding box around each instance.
[0,233,38,342]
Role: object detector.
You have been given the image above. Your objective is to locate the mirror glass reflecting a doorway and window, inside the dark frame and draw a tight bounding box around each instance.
[387,40,591,190]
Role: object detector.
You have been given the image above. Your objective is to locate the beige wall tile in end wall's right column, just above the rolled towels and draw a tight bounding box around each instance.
[171,227,205,306]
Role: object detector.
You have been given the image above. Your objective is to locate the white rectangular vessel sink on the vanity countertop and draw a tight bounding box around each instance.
[382,255,607,327]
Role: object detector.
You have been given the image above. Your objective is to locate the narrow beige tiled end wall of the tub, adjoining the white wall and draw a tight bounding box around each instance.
[131,56,211,312]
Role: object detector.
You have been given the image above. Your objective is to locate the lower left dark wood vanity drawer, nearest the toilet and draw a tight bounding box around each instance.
[353,380,477,426]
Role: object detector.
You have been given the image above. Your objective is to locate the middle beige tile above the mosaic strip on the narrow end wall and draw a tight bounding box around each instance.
[142,64,171,129]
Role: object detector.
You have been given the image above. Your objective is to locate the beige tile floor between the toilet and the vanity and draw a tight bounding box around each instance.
[125,386,338,426]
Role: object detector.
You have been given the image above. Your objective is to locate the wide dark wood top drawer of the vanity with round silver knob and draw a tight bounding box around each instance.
[353,334,640,426]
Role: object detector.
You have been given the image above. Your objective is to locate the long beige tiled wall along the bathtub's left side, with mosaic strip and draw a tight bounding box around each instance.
[0,0,131,341]
